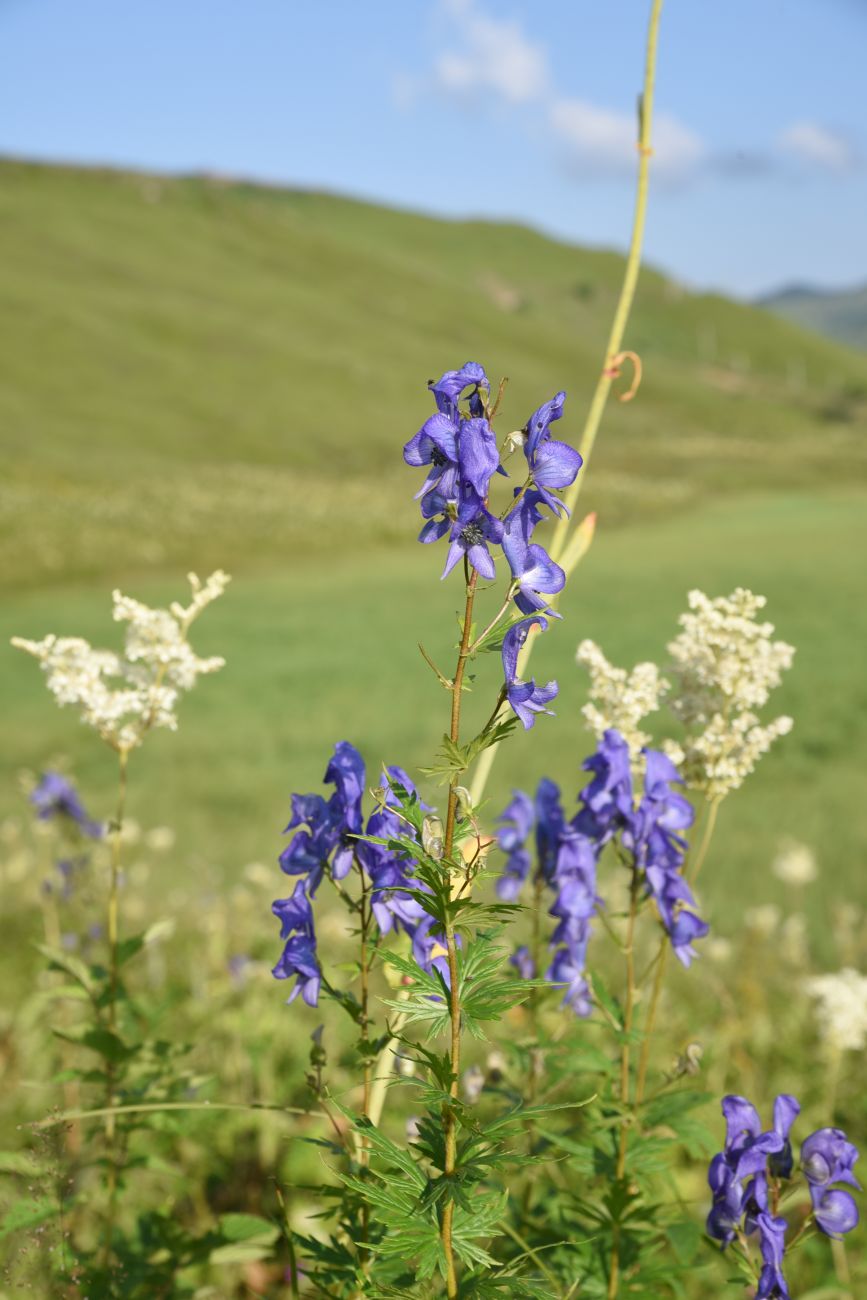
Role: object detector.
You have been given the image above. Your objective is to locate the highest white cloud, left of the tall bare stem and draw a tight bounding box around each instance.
[434,0,549,104]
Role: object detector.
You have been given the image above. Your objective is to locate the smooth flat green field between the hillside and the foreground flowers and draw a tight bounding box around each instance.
[6,490,867,956]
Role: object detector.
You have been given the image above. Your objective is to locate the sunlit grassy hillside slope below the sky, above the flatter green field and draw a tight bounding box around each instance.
[0,161,867,585]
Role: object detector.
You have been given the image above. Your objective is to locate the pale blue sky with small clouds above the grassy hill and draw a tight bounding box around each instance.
[0,0,867,295]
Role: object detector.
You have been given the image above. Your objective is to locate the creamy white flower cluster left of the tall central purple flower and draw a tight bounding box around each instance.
[12,569,229,751]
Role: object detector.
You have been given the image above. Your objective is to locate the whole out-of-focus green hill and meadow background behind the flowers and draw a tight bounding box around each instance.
[0,149,867,1295]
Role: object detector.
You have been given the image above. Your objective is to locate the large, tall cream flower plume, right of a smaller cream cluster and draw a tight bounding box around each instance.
[668,588,794,798]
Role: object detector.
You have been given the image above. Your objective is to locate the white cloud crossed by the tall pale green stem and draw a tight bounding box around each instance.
[549,99,706,179]
